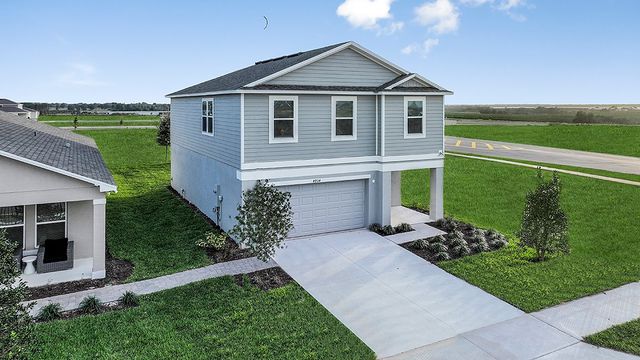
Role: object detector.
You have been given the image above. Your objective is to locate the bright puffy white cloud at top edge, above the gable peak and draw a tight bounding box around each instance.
[336,0,393,29]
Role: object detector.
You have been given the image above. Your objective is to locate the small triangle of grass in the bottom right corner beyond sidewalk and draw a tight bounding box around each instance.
[585,319,640,355]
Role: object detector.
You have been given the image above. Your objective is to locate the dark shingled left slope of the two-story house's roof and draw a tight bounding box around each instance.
[167,43,345,96]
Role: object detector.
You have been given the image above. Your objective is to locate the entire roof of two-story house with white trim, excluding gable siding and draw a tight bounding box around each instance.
[167,42,449,97]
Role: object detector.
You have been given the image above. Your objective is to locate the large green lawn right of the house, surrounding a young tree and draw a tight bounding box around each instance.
[402,156,640,312]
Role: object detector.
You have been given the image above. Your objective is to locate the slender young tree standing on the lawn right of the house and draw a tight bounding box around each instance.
[518,169,569,261]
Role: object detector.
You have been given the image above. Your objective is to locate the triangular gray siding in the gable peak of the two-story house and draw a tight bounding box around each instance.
[267,49,398,86]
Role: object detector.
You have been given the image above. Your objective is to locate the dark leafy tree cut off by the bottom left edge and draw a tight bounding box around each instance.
[0,229,33,359]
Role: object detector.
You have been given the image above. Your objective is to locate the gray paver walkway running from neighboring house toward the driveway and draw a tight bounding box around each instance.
[25,257,277,315]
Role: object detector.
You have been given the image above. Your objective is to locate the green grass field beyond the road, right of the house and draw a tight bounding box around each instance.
[445,125,640,157]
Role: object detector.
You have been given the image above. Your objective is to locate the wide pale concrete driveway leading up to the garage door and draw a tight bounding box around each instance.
[274,230,523,357]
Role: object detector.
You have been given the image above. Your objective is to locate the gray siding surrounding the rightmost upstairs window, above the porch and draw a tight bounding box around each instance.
[385,96,444,156]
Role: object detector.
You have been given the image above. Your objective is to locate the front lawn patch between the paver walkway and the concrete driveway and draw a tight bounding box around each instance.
[35,277,375,359]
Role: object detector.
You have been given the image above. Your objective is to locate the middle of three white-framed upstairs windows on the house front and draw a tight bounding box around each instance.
[331,96,358,141]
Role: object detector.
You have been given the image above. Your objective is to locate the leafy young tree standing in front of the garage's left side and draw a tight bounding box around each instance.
[230,180,293,261]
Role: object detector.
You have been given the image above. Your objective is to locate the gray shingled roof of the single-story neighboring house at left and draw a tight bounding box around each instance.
[0,112,116,191]
